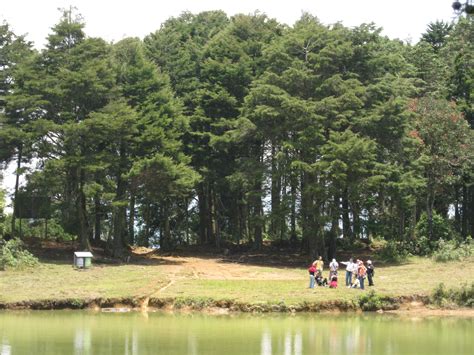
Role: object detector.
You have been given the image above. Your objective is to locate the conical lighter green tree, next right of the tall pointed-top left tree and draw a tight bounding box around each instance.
[114,39,199,249]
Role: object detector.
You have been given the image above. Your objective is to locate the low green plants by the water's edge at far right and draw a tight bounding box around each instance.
[430,282,474,307]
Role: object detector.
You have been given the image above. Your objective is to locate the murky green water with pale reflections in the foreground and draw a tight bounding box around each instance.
[0,311,474,355]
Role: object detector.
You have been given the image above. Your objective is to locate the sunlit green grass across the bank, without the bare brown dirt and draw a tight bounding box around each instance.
[0,254,474,305]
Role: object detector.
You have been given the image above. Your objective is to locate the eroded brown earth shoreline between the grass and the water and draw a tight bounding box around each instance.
[0,295,474,318]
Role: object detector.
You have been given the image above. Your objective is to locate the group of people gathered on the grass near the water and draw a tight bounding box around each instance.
[308,256,375,290]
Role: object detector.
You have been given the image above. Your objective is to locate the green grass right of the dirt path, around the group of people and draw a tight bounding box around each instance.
[159,258,474,304]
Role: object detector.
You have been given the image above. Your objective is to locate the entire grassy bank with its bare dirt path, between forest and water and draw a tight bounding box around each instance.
[0,252,474,311]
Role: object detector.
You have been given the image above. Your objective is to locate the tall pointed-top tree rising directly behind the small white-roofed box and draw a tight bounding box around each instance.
[27,9,115,249]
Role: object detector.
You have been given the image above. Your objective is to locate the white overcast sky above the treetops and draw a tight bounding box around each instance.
[0,0,453,48]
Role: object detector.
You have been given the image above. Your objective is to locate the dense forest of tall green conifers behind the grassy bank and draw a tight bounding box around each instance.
[0,9,474,257]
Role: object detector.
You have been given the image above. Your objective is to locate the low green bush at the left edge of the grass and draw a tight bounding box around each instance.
[0,239,38,270]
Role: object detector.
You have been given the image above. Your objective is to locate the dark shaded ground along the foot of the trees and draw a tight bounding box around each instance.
[26,238,411,271]
